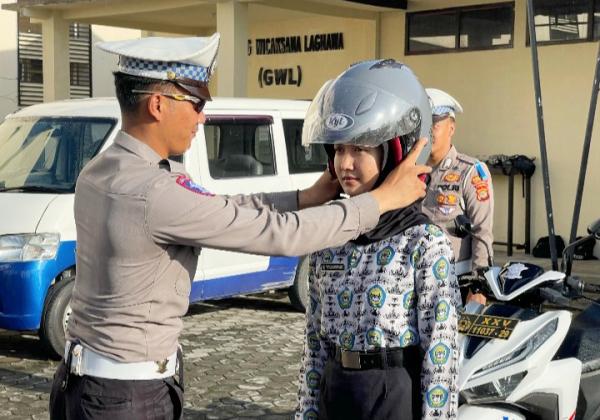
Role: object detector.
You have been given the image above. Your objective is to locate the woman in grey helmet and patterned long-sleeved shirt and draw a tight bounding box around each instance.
[296,60,460,420]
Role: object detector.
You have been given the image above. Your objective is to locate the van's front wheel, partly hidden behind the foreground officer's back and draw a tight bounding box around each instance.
[39,270,75,358]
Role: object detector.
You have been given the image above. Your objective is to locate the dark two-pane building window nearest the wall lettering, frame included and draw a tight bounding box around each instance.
[406,3,515,55]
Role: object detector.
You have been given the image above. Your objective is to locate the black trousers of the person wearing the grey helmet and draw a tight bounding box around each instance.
[319,352,422,420]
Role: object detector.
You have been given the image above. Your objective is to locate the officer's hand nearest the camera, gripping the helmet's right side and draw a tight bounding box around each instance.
[371,138,431,214]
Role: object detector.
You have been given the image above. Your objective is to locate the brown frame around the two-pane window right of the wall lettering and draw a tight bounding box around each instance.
[404,1,515,56]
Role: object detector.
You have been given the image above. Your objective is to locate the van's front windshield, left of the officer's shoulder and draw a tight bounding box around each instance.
[0,117,116,192]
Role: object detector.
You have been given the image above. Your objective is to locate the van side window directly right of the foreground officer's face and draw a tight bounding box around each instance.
[204,115,276,179]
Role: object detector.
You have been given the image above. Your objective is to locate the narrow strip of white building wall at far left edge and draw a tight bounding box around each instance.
[0,0,18,120]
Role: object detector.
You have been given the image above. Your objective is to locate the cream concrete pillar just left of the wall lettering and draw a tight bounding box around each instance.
[216,0,248,97]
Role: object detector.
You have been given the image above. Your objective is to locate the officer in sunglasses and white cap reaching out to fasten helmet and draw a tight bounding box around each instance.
[50,34,430,420]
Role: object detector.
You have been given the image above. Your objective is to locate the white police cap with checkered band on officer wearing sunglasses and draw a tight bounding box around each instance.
[96,32,220,100]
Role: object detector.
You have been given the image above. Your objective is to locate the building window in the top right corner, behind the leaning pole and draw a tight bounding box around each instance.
[527,0,600,45]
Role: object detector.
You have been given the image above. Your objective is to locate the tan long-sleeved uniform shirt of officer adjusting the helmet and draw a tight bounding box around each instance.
[67,132,379,362]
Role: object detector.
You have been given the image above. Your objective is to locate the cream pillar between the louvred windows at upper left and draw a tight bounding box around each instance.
[41,12,70,102]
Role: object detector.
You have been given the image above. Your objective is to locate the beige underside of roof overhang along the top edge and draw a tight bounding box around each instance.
[2,0,407,35]
